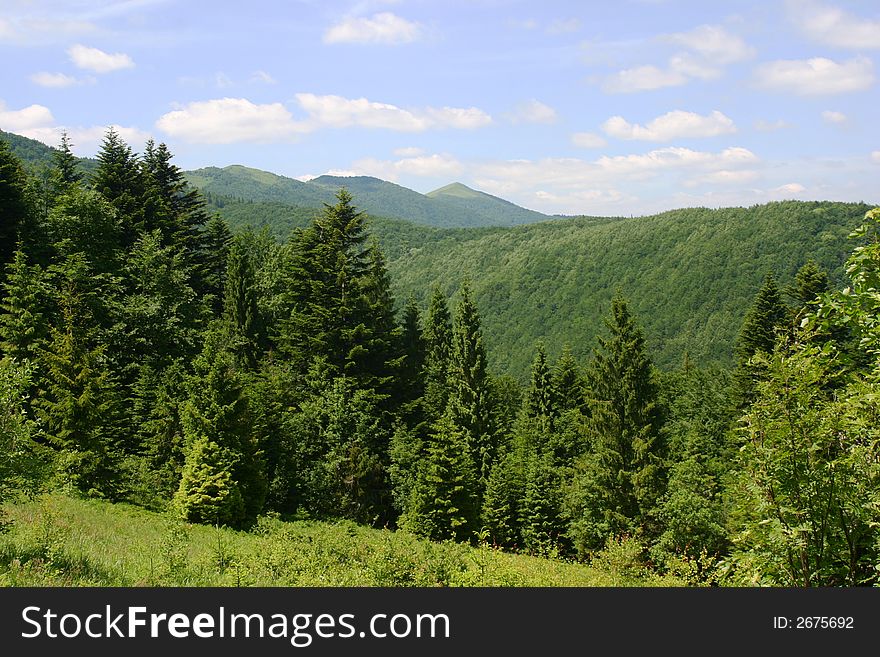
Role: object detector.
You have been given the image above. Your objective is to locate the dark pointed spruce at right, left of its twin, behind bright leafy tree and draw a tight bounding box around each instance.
[734,274,788,408]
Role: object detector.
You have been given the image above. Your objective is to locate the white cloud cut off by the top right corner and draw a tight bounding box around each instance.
[788,0,880,50]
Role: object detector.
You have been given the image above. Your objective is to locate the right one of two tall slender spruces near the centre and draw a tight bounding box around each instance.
[449,283,495,500]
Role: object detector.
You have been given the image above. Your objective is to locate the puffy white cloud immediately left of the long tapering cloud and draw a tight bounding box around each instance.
[156,98,304,144]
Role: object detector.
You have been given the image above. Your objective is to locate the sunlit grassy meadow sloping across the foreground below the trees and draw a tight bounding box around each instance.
[0,494,683,587]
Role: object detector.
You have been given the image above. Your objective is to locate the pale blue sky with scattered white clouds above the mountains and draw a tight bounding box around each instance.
[0,0,880,215]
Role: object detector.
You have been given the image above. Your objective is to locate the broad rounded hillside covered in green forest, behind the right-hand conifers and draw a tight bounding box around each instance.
[382,201,870,377]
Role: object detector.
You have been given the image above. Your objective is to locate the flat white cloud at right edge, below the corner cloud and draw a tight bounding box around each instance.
[755,57,874,96]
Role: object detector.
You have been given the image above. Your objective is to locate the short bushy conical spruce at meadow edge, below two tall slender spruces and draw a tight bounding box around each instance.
[402,415,479,541]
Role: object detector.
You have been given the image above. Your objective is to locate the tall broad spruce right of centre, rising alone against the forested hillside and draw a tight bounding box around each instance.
[571,296,664,551]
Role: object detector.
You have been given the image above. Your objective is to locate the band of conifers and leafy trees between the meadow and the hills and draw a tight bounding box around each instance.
[0,130,880,586]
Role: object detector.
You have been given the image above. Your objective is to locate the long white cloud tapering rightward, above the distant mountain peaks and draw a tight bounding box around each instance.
[296,93,492,132]
